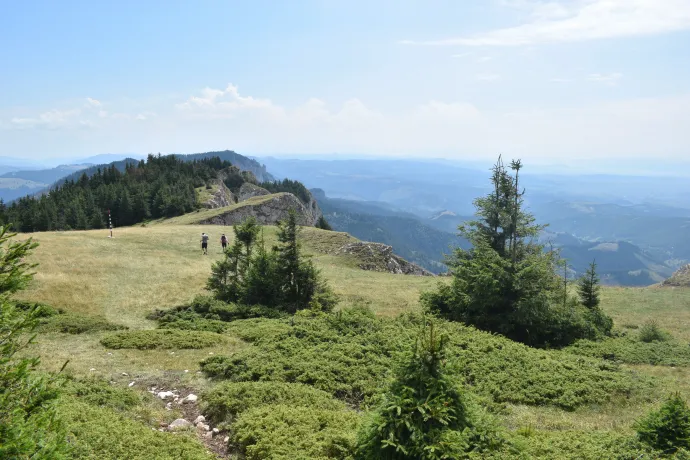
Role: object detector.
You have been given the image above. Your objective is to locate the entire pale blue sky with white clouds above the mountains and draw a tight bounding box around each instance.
[0,0,690,165]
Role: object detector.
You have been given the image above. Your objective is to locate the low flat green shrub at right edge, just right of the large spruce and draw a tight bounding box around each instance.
[565,336,690,366]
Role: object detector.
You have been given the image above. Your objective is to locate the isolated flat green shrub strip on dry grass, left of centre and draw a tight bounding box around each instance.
[101,329,224,350]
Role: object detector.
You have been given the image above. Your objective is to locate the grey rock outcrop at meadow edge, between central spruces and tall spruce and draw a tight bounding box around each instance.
[336,242,434,276]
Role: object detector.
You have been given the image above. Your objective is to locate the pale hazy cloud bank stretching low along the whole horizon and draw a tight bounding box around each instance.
[0,85,690,159]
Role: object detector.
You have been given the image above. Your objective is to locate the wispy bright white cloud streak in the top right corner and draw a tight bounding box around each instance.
[401,0,690,46]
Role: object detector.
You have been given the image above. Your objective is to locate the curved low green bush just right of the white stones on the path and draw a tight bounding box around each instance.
[202,382,345,424]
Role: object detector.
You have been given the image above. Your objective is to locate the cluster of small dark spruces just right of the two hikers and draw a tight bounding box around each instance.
[206,211,337,313]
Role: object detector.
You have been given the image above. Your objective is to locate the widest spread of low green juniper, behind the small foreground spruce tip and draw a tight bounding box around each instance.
[201,308,649,409]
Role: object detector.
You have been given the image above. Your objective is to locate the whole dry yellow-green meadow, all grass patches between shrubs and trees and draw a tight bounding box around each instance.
[14,221,690,458]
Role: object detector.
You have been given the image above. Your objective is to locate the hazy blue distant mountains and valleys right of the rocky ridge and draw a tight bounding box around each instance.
[260,158,690,286]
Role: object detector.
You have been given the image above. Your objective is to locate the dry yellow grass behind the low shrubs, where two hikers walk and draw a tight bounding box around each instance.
[17,224,434,328]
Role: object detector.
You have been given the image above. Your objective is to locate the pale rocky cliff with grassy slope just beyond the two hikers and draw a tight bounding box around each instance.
[199,193,318,227]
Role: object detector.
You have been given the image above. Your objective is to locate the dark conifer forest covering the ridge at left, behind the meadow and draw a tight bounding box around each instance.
[0,155,236,232]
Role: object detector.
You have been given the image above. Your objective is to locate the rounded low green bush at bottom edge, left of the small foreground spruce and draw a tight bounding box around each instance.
[231,404,360,460]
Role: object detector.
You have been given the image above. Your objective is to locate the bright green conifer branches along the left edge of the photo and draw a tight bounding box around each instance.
[0,227,68,460]
